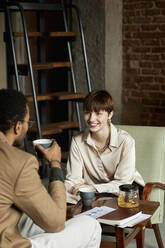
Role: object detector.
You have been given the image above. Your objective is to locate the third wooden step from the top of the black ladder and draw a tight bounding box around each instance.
[26,91,85,102]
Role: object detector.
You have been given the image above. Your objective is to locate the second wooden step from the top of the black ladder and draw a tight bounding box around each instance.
[33,62,71,70]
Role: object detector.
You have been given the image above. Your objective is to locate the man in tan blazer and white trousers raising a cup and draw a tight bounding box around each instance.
[0,89,101,248]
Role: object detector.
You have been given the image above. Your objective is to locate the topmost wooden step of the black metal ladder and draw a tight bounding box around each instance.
[13,32,76,38]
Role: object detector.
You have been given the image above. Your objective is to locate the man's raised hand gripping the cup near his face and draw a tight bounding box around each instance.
[35,140,61,168]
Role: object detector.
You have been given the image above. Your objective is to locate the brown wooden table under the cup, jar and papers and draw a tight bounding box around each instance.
[67,197,160,248]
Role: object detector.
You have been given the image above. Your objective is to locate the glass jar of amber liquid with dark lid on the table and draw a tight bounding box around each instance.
[118,184,139,208]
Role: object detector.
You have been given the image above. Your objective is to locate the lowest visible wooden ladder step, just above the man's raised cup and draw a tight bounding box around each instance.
[29,121,79,135]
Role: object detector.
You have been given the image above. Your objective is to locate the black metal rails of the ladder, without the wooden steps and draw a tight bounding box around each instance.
[2,0,91,138]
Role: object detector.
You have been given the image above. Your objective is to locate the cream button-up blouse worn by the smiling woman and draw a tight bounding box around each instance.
[65,124,144,203]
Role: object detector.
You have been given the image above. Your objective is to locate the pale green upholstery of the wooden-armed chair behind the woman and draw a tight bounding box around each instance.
[115,125,165,224]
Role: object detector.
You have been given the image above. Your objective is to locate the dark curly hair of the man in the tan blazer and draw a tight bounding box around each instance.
[0,89,27,133]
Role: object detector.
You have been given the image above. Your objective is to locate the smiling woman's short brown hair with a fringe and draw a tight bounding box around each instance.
[83,90,114,113]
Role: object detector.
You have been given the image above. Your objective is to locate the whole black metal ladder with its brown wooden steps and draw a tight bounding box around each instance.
[3,0,91,176]
